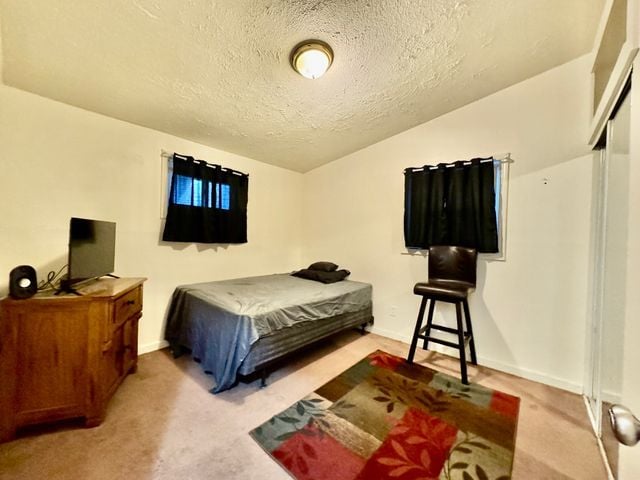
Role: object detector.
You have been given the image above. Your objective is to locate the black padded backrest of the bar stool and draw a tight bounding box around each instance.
[429,245,478,287]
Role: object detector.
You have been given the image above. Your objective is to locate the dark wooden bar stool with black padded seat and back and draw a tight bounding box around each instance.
[407,245,478,385]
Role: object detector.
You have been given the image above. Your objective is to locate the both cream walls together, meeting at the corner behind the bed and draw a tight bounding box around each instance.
[0,58,591,391]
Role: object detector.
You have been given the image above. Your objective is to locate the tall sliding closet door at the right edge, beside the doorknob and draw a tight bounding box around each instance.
[593,82,631,476]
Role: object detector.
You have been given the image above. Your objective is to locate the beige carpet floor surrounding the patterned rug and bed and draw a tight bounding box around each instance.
[0,332,606,480]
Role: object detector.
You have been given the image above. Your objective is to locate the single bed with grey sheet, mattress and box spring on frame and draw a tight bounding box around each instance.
[165,274,373,393]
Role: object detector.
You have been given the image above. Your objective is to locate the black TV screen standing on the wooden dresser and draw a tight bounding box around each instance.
[67,218,116,284]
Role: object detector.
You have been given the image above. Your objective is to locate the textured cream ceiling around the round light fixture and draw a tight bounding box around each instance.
[0,0,604,172]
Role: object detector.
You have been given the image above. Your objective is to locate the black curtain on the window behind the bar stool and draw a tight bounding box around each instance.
[404,158,498,253]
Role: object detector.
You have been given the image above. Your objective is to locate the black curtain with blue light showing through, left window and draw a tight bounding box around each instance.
[162,154,249,243]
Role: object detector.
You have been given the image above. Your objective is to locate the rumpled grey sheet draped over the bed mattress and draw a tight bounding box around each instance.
[165,274,371,393]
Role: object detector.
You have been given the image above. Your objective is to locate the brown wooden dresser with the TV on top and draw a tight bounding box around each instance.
[0,278,146,442]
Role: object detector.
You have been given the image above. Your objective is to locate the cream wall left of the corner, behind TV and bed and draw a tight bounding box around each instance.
[0,85,302,351]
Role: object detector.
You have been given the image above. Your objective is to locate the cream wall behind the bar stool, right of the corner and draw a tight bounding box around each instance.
[303,57,592,391]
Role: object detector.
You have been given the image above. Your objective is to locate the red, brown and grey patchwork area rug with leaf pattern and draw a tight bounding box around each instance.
[250,350,520,480]
